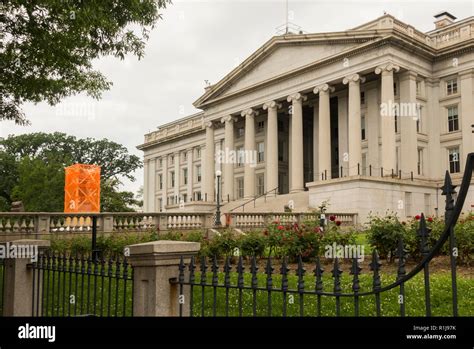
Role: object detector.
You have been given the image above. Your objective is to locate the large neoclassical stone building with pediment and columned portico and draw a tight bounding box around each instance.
[138,12,474,221]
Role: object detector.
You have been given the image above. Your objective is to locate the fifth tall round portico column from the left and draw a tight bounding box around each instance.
[287,93,307,193]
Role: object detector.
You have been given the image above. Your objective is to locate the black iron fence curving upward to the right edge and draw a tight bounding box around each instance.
[175,153,474,316]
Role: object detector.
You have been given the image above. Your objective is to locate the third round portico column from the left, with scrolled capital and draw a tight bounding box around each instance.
[241,108,258,198]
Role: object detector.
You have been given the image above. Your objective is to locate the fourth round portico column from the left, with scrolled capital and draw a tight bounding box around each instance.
[263,101,281,191]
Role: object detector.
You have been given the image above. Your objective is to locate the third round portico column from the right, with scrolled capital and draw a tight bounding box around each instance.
[313,84,334,179]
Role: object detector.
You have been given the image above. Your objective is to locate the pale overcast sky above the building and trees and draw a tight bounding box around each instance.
[0,0,474,191]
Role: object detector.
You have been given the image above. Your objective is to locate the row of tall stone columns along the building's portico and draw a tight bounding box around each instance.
[203,63,417,198]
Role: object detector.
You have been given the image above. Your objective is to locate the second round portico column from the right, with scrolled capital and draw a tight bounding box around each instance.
[342,74,365,176]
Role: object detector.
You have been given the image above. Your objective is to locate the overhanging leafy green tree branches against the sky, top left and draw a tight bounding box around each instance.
[0,0,170,124]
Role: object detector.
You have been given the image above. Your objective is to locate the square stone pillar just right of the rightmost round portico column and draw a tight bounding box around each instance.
[399,71,419,178]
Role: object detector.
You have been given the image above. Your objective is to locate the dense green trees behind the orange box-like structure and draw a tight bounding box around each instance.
[0,132,142,212]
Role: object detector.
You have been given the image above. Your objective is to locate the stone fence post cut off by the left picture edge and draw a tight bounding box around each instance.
[0,239,50,316]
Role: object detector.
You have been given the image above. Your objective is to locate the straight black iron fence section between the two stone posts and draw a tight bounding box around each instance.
[31,254,133,316]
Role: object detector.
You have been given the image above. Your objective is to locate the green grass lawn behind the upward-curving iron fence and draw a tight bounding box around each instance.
[193,272,474,316]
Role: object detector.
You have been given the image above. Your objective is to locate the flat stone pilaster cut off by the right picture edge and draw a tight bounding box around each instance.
[459,68,474,167]
